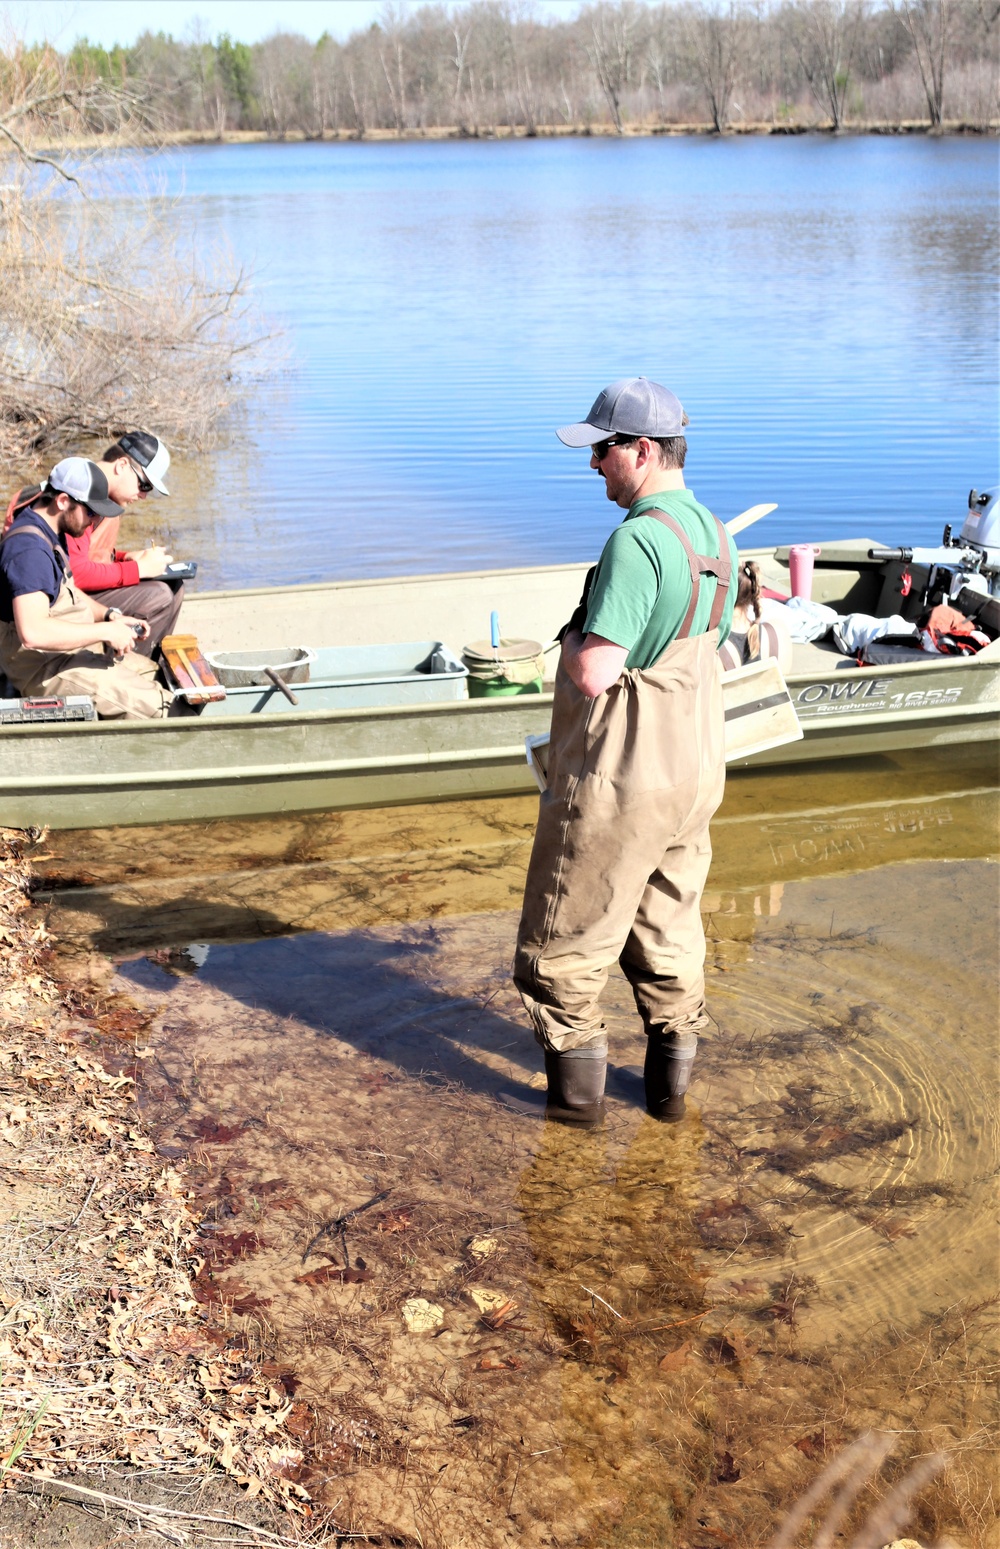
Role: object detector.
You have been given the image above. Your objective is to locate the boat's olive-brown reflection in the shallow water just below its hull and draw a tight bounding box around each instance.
[36,745,997,956]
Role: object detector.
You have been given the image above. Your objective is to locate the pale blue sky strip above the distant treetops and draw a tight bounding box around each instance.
[11,0,582,48]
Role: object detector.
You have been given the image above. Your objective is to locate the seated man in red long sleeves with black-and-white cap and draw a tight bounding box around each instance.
[5,431,184,657]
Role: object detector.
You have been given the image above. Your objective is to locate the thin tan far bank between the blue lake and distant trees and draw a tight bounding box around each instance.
[37,119,1000,155]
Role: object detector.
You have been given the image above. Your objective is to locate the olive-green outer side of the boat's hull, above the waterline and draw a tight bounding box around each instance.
[0,663,1000,829]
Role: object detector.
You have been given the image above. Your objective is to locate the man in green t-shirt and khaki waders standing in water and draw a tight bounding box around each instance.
[514,376,737,1123]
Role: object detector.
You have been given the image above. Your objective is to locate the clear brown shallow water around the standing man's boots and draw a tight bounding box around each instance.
[43,750,998,1549]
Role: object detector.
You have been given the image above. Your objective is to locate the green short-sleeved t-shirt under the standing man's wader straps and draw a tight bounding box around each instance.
[584,489,738,669]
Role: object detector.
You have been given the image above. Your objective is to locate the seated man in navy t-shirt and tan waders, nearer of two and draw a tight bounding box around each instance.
[0,457,172,720]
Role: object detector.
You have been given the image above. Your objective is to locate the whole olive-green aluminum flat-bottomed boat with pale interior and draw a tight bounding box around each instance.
[0,539,1000,829]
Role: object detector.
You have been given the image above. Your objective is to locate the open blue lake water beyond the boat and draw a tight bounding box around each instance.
[111,136,997,586]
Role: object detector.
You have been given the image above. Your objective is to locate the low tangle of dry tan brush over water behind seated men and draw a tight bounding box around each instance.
[0,167,266,465]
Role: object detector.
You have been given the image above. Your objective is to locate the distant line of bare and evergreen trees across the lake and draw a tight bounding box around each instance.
[56,0,1000,138]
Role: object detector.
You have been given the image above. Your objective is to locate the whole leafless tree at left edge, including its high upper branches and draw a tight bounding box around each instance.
[0,48,267,463]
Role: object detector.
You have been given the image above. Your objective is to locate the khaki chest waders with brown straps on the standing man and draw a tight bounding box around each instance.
[514,513,732,1118]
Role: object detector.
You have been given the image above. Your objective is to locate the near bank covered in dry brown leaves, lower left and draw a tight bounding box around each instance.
[0,829,324,1544]
